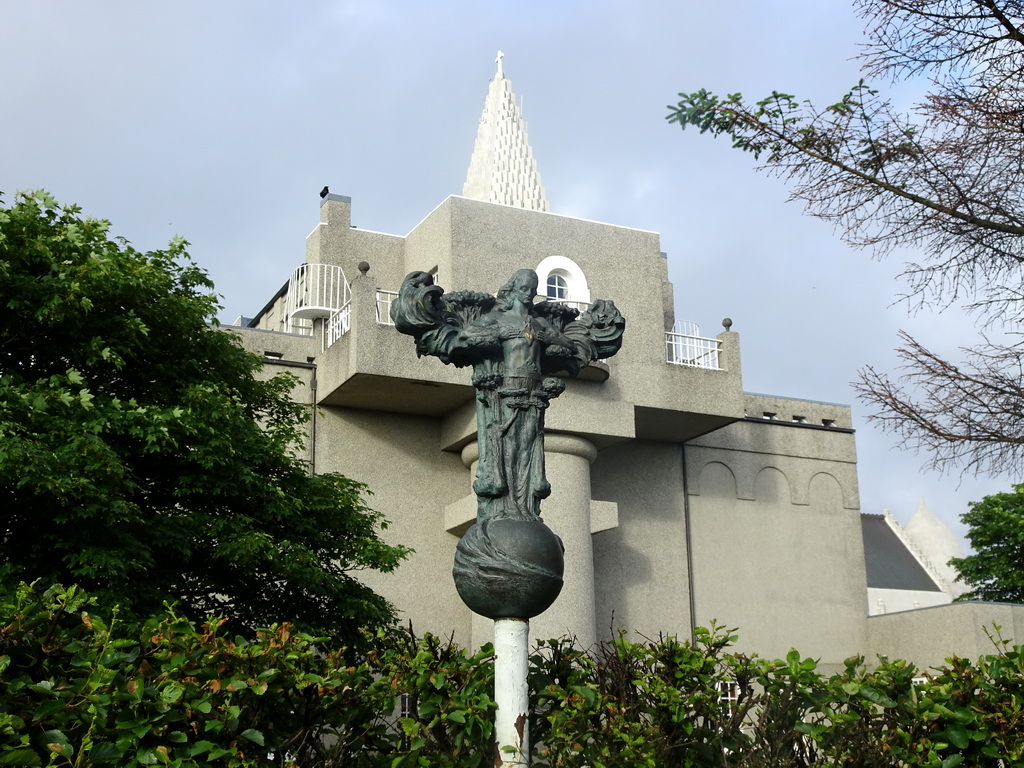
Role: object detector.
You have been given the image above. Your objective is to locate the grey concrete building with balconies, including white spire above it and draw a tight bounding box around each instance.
[232,57,1024,665]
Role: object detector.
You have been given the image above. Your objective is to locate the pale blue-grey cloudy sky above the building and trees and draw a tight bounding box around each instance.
[0,0,1019,552]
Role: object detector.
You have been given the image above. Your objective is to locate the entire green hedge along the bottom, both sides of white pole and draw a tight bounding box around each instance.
[6,585,1024,768]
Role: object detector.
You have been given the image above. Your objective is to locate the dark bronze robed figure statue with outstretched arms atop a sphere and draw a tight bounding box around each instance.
[391,269,626,618]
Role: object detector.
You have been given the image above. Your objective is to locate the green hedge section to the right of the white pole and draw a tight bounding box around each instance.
[532,626,1024,768]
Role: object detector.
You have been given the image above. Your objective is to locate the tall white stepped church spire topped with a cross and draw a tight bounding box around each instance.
[462,51,548,211]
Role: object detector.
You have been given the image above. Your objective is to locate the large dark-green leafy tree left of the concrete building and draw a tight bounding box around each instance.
[0,194,406,642]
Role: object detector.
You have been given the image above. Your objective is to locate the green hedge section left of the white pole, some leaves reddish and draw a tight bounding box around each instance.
[0,585,495,768]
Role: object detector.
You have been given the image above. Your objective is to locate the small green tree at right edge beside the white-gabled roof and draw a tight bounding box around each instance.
[951,485,1024,603]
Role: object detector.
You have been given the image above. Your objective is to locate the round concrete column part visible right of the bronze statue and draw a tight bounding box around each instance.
[530,433,597,648]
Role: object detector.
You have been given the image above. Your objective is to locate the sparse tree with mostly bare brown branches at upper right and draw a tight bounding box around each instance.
[668,0,1024,473]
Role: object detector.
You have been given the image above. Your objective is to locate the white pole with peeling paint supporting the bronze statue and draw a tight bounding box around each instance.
[495,618,529,768]
